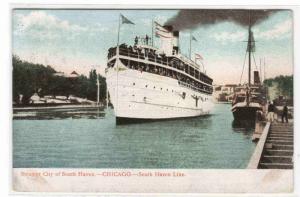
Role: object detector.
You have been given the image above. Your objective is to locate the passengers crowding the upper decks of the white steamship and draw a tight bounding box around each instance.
[108,37,212,92]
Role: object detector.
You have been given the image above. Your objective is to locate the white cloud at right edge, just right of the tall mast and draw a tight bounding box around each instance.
[255,19,293,40]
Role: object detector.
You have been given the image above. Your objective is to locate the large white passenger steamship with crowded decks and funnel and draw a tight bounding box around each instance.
[106,23,213,124]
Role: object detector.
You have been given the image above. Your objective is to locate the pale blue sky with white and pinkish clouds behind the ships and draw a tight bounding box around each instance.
[12,9,293,84]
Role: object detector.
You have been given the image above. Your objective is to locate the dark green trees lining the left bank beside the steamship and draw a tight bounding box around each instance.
[12,55,106,103]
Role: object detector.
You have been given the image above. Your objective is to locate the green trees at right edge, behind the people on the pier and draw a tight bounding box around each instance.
[264,75,294,97]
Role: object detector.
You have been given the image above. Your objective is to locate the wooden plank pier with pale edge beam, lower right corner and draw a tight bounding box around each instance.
[248,122,294,169]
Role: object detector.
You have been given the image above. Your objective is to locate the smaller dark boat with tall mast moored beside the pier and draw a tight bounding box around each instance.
[231,24,266,123]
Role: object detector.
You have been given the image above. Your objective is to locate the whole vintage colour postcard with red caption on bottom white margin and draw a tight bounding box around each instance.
[11,6,294,194]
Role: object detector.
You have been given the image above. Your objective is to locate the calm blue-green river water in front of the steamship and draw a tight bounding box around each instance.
[13,104,255,169]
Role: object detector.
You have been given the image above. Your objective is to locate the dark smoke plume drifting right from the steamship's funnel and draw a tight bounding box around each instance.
[165,9,279,31]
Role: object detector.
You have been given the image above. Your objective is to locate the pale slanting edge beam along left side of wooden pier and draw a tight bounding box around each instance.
[247,122,271,169]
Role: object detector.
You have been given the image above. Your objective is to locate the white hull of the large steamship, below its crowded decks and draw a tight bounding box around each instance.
[106,61,213,124]
